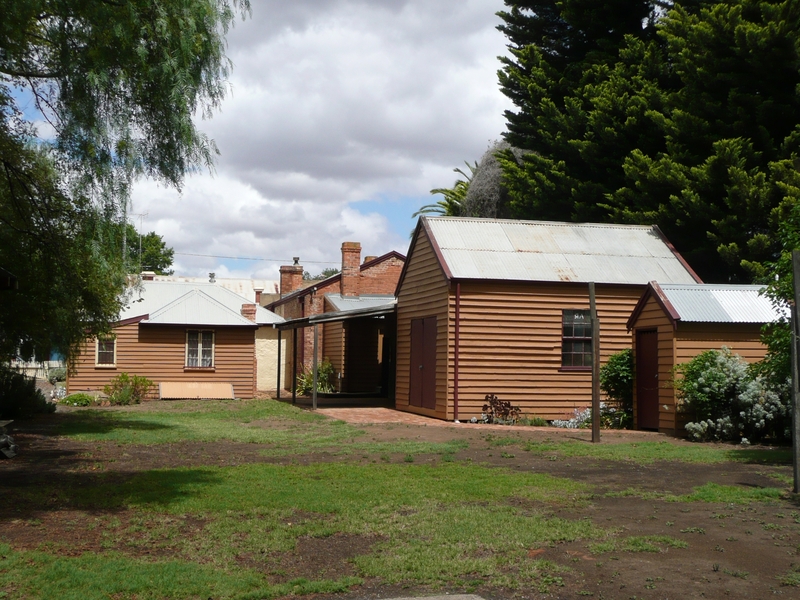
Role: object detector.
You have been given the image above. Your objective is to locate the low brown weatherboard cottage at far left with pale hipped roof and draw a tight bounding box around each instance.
[67,281,283,398]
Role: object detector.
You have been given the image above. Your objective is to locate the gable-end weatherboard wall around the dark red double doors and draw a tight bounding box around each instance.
[395,229,453,419]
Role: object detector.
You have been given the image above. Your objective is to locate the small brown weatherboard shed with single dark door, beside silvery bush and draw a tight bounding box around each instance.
[628,281,781,433]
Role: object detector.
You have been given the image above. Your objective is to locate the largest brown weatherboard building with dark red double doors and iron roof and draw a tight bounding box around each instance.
[395,217,700,420]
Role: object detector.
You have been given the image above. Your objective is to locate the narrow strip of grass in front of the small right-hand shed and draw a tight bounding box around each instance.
[522,440,792,464]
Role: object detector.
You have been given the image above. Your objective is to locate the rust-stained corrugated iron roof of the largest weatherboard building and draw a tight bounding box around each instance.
[424,217,697,285]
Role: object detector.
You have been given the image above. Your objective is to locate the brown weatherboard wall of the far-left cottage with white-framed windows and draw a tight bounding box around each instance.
[67,323,256,398]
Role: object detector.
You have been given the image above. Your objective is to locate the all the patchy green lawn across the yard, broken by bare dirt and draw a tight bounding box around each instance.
[0,401,796,600]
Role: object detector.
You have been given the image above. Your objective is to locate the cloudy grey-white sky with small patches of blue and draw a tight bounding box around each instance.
[132,0,510,279]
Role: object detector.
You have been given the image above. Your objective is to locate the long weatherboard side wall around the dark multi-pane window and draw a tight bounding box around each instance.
[448,282,644,419]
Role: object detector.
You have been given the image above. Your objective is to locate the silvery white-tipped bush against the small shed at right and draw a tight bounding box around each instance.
[673,347,791,442]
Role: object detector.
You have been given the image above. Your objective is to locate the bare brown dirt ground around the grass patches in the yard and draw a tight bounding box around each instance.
[0,404,800,600]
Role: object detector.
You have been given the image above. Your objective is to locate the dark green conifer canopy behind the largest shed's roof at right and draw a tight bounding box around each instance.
[500,0,800,282]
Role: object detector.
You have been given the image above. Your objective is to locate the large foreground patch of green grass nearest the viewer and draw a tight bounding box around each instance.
[0,462,610,598]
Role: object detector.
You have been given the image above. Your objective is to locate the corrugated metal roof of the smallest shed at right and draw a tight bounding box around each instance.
[659,283,784,323]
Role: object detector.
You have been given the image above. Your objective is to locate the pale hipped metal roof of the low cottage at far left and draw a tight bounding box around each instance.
[120,281,283,327]
